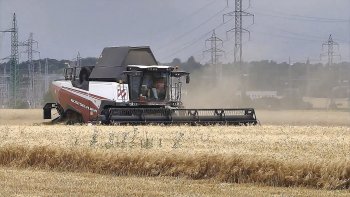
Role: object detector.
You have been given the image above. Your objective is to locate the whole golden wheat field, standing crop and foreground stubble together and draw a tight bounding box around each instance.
[0,110,350,196]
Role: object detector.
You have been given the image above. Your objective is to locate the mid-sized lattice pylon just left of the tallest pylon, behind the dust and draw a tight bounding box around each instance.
[203,29,225,82]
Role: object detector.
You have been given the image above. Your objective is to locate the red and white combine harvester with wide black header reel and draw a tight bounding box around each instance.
[43,47,257,125]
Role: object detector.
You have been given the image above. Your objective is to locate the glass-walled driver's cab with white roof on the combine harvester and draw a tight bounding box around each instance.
[121,65,190,107]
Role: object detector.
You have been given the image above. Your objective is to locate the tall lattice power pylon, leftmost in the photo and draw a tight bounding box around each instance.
[0,13,19,108]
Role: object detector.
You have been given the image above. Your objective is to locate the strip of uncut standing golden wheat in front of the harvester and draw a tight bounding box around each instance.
[0,126,350,189]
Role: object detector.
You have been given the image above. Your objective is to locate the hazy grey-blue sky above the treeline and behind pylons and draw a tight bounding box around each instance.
[0,0,350,63]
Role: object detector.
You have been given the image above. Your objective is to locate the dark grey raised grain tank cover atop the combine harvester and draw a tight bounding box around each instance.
[90,47,158,81]
